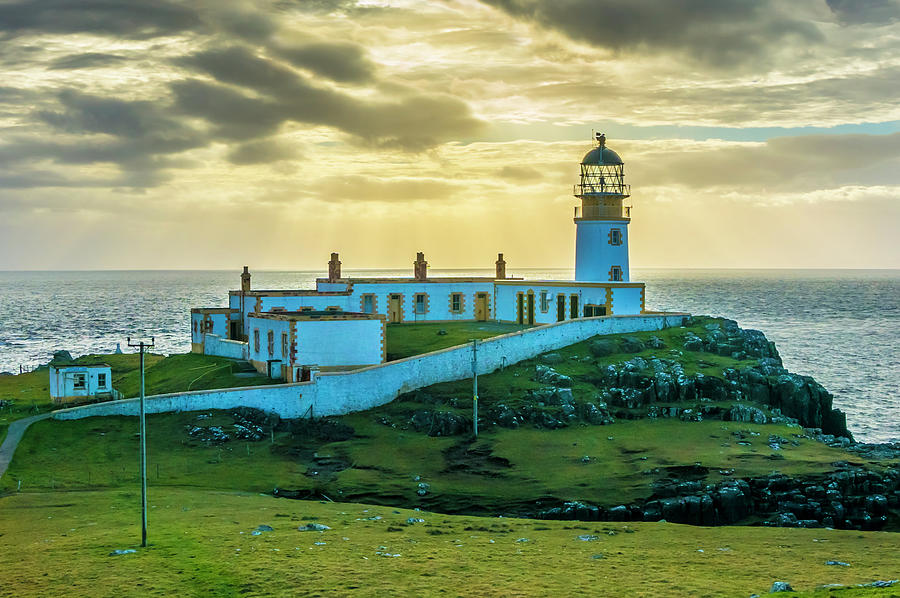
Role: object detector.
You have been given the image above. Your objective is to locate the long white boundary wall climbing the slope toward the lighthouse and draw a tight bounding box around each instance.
[52,313,687,419]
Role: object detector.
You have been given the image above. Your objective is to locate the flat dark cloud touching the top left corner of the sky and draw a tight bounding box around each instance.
[0,0,201,39]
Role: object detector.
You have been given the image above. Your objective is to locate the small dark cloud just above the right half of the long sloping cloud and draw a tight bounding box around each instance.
[275,41,375,83]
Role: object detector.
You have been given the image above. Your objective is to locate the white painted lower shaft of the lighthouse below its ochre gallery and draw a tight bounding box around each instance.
[575,220,631,282]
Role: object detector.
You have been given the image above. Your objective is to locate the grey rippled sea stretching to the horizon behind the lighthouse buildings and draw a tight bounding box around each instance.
[0,269,900,442]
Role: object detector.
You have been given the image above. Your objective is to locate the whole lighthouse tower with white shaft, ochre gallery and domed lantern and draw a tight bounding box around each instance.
[575,133,631,282]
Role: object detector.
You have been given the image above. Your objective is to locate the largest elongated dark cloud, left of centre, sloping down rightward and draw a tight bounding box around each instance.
[173,46,482,151]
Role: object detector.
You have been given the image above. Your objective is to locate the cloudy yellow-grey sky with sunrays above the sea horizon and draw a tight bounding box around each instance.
[0,0,900,270]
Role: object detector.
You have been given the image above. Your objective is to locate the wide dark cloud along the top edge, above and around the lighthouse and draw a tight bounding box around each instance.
[481,0,822,67]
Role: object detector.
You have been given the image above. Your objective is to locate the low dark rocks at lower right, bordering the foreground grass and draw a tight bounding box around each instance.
[536,464,900,530]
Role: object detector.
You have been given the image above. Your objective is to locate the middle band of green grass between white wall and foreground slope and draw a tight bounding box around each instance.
[0,412,881,513]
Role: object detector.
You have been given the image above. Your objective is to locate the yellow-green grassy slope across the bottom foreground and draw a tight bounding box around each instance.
[0,487,898,597]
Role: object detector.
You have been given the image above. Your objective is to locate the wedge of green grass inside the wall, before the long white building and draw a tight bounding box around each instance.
[385,322,529,361]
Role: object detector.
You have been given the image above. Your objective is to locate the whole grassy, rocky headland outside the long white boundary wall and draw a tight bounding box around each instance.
[0,318,900,596]
